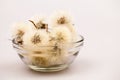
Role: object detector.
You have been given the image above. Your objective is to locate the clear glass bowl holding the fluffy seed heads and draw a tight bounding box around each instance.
[12,35,84,72]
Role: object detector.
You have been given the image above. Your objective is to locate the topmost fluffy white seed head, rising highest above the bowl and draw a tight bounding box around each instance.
[49,11,75,32]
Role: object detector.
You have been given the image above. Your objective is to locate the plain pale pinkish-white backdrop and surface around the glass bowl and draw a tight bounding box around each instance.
[0,0,120,80]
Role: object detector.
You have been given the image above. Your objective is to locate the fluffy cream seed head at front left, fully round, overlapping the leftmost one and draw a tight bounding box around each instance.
[23,30,49,51]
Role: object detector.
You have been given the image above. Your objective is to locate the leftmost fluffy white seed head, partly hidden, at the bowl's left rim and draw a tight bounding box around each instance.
[12,22,31,45]
